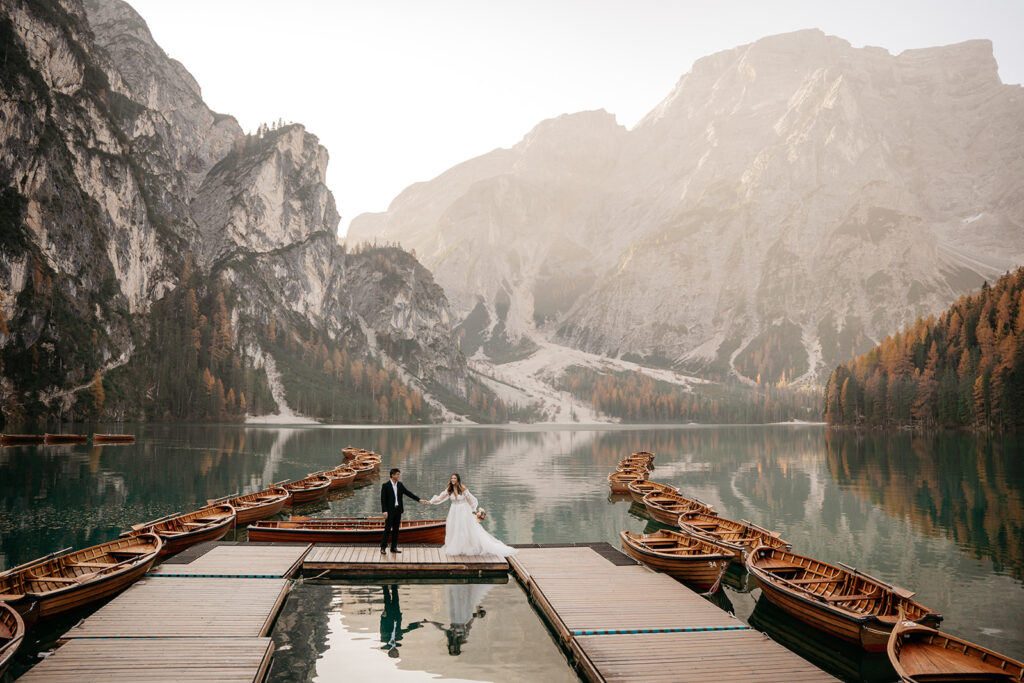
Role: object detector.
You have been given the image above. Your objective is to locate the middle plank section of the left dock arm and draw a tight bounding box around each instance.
[63,579,289,653]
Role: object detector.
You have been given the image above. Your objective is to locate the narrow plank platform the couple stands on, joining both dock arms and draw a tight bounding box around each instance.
[302,544,509,578]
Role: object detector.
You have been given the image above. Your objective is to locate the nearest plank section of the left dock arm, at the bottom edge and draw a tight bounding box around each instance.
[18,638,273,683]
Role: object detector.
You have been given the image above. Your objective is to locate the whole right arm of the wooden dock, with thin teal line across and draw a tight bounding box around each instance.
[509,544,835,682]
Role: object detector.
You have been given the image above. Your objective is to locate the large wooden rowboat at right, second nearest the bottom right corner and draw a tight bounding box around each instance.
[746,546,942,652]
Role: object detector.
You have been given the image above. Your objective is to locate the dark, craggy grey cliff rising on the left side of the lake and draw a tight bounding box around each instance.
[0,0,466,421]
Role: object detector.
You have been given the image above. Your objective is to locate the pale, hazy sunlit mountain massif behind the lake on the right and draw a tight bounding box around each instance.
[349,31,1024,382]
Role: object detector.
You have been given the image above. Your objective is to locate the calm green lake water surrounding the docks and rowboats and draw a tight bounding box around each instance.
[0,425,1024,681]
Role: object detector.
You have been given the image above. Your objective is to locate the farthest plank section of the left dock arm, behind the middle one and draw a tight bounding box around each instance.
[146,544,312,579]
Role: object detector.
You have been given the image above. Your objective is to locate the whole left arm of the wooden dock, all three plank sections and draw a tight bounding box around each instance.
[18,543,309,683]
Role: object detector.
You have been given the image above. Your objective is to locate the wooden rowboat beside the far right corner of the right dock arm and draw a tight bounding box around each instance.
[618,530,732,593]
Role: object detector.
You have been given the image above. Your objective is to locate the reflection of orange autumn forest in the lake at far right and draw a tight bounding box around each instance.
[825,431,1024,580]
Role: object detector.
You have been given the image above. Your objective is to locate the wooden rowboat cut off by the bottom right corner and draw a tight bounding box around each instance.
[887,610,1024,683]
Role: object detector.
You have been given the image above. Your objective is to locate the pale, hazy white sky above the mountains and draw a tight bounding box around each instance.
[129,0,1024,233]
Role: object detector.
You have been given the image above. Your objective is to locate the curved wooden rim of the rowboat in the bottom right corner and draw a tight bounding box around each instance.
[886,606,1024,683]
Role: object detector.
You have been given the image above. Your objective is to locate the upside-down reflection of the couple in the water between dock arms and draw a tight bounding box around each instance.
[381,584,494,657]
